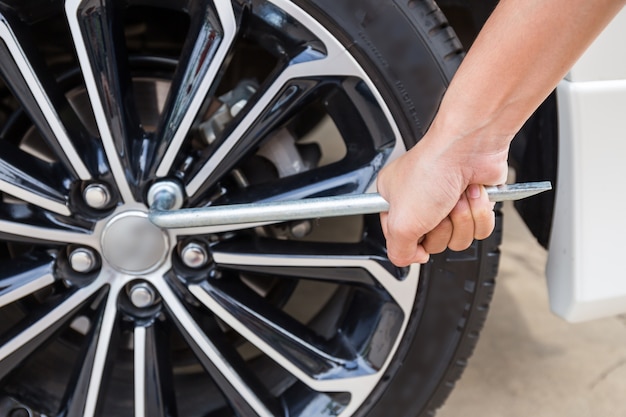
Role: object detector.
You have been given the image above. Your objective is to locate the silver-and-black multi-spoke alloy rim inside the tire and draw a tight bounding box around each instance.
[0,0,419,417]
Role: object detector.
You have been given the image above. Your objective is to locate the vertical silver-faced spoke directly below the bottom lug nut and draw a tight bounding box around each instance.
[134,323,177,417]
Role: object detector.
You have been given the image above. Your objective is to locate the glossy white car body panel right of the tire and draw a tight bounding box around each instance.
[547,9,626,321]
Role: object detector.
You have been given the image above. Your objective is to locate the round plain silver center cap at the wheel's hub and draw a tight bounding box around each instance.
[101,211,169,275]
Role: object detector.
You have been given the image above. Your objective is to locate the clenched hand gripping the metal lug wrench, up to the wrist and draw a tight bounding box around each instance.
[377,133,507,266]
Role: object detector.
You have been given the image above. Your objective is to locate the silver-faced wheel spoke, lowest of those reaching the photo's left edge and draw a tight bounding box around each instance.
[0,276,101,379]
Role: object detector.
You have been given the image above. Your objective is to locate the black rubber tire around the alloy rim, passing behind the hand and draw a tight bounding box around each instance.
[298,0,502,417]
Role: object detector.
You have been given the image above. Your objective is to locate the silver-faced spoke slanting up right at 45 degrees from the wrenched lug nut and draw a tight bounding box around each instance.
[186,49,364,197]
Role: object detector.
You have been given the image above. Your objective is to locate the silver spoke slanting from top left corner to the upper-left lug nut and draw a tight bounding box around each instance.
[0,15,91,180]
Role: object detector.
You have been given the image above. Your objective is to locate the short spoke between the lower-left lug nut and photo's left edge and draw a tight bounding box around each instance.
[0,252,55,307]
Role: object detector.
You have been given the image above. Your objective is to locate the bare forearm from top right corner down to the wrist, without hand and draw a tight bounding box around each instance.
[424,0,626,183]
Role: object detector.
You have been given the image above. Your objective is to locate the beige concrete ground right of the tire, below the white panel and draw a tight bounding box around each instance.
[437,200,626,417]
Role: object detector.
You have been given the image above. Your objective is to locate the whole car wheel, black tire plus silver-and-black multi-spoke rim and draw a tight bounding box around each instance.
[0,0,501,417]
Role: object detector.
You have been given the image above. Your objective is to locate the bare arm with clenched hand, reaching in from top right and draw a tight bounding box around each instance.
[378,0,626,266]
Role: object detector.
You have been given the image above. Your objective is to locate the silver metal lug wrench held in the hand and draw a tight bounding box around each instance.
[148,181,552,229]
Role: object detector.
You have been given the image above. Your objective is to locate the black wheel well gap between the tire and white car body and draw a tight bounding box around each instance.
[437,0,558,247]
